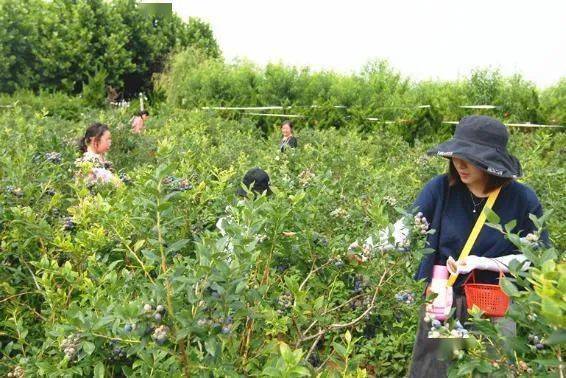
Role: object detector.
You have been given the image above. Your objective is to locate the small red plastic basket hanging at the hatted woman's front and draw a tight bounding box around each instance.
[464,271,509,318]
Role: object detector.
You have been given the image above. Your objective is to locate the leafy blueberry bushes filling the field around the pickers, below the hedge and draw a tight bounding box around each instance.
[0,98,566,377]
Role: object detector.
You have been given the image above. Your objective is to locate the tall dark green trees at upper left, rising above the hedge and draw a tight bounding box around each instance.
[0,0,220,96]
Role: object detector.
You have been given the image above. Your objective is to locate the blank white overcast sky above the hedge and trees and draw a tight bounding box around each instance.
[162,0,566,87]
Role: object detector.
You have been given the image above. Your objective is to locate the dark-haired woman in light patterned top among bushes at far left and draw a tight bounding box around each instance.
[75,122,122,185]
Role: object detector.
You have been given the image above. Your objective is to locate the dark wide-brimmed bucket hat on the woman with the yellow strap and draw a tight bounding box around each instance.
[428,116,523,178]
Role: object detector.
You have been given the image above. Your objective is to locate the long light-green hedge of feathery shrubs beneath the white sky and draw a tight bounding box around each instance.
[158,50,566,139]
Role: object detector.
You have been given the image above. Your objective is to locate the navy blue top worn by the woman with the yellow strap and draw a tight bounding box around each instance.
[413,175,548,287]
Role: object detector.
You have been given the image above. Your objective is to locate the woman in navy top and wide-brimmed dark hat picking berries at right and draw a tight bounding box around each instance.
[409,116,548,377]
